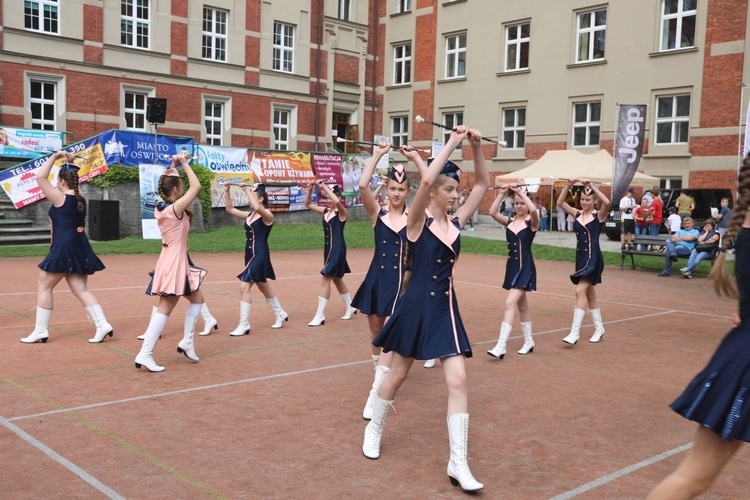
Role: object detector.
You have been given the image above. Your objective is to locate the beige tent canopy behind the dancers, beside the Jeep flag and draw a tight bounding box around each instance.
[495,149,659,187]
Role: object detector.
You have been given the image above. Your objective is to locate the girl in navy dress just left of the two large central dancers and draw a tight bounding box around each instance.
[305,180,357,326]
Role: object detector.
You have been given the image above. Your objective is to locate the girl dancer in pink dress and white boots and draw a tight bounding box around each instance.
[135,154,206,372]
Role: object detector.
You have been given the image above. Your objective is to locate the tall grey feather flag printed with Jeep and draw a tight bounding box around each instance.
[612,104,646,203]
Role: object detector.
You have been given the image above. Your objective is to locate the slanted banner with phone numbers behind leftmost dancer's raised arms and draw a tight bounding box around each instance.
[0,137,107,208]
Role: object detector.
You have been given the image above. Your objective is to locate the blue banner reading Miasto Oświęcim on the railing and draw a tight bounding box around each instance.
[99,130,195,167]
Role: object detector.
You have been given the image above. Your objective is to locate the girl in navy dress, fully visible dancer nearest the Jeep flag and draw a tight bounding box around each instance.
[557,179,609,345]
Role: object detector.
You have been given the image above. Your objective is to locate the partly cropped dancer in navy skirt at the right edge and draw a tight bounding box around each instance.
[648,158,750,500]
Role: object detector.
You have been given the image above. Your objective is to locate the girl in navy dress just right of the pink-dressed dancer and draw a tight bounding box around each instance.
[224,184,289,337]
